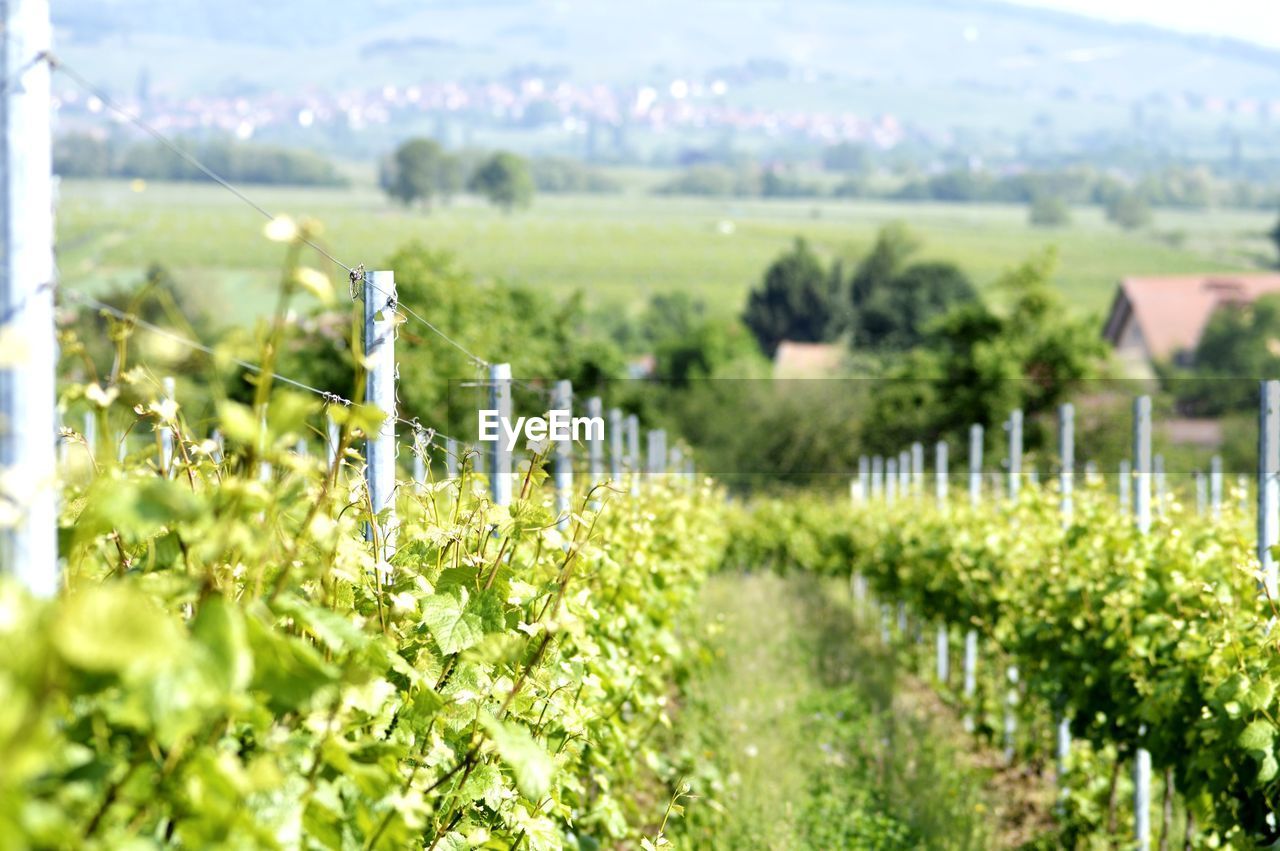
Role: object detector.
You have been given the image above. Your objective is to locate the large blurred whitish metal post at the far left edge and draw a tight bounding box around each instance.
[0,0,59,596]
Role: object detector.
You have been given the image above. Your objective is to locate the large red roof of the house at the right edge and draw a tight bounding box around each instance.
[1105,274,1280,360]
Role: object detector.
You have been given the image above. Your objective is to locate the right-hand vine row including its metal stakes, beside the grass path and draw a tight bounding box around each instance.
[732,404,1280,848]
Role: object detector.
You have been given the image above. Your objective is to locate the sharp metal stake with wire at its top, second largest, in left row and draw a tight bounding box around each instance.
[365,271,397,562]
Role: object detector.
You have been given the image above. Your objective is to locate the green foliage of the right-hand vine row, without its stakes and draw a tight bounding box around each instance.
[731,480,1280,847]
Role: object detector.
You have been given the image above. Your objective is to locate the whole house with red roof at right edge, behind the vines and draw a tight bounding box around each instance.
[1102,274,1280,378]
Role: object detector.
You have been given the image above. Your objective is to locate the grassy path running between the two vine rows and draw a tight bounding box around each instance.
[673,573,1052,850]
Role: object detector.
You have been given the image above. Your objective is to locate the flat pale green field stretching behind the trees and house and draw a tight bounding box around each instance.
[58,180,1271,321]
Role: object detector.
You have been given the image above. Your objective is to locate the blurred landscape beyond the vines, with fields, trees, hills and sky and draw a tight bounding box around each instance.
[54,0,1280,486]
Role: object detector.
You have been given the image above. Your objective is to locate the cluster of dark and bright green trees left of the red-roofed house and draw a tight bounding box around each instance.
[742,224,1106,462]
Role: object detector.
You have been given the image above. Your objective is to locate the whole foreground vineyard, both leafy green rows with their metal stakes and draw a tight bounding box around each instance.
[15,246,1280,848]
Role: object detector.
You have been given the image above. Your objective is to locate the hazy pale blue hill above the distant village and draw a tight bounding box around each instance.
[54,0,1280,157]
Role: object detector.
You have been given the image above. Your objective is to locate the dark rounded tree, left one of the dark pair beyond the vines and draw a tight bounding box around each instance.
[742,237,835,357]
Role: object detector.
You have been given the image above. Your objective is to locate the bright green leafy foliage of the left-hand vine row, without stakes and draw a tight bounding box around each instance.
[27,237,723,850]
